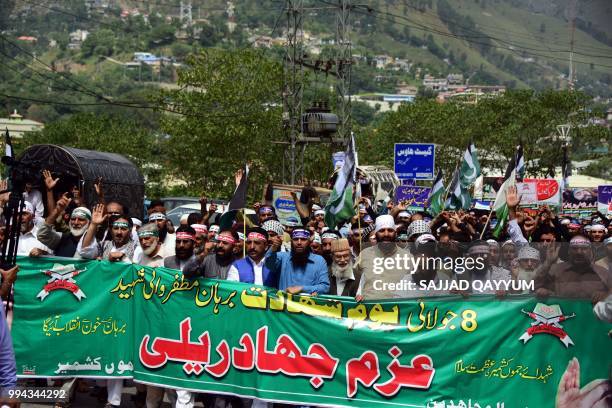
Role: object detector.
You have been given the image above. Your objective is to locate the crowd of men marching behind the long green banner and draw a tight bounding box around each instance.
[0,171,612,408]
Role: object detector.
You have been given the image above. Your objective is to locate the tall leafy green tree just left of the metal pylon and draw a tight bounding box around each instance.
[158,49,285,198]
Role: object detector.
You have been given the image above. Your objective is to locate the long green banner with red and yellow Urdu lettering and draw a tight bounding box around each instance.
[12,258,612,408]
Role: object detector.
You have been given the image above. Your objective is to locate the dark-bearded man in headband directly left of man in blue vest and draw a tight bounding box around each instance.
[183,230,238,279]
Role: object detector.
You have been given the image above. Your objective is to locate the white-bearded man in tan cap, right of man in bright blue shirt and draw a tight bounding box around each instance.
[329,238,361,297]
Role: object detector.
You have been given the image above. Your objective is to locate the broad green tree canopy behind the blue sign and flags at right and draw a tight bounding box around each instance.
[361,90,596,176]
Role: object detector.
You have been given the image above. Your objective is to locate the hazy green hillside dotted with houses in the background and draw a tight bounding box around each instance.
[0,0,612,118]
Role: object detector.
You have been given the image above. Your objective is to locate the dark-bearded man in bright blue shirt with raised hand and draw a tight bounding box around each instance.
[266,228,329,295]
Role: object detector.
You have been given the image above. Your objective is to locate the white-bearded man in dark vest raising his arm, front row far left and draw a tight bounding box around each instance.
[36,195,91,258]
